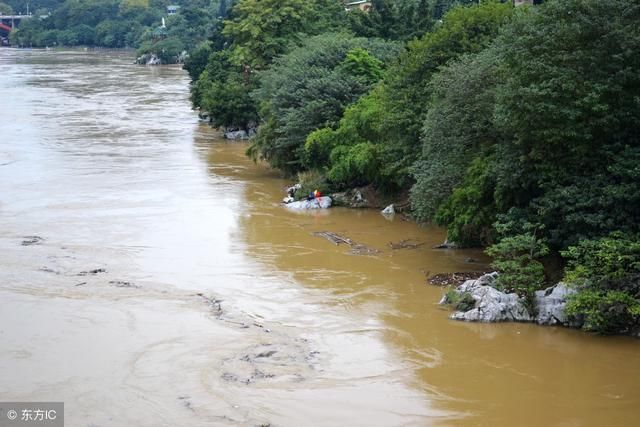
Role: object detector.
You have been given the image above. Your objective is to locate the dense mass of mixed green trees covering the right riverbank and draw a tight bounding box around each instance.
[188,0,640,333]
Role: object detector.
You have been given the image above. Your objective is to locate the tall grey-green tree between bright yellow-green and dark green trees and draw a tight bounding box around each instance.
[411,49,502,224]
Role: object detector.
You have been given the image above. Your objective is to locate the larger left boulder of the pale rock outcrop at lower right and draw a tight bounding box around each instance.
[440,273,533,322]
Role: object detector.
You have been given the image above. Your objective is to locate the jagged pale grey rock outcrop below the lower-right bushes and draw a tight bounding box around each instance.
[440,272,579,326]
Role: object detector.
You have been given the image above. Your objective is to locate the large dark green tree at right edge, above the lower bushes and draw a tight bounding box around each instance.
[496,0,640,247]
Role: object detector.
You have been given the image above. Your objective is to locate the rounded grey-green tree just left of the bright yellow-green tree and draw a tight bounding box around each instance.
[246,33,398,173]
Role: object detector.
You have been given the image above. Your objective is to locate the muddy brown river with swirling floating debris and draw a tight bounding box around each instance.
[0,49,640,427]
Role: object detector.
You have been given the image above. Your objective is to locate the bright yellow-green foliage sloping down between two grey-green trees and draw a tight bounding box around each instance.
[308,2,512,191]
